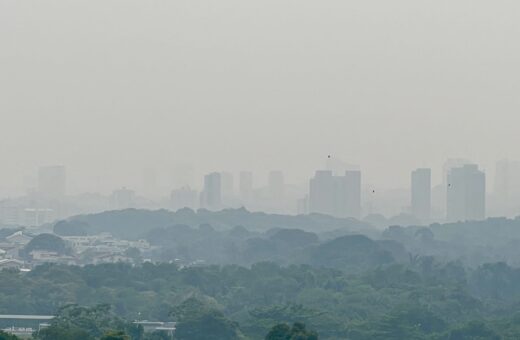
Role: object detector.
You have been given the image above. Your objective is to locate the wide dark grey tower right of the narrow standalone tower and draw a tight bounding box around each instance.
[446,164,486,222]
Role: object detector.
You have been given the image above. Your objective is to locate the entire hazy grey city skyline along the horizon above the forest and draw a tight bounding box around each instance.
[0,157,520,226]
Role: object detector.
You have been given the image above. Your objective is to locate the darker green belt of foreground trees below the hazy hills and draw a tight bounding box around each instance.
[0,257,520,340]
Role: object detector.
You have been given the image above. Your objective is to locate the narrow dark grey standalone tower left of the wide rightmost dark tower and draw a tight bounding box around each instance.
[411,169,432,223]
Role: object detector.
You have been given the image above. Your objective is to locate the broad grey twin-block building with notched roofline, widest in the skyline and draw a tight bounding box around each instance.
[309,170,361,218]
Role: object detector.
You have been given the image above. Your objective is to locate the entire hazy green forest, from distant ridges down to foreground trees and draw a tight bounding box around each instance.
[5,210,520,340]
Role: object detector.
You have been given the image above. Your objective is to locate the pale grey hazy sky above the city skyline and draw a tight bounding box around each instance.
[0,0,520,194]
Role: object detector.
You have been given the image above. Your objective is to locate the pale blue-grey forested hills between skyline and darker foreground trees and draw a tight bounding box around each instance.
[58,209,520,267]
